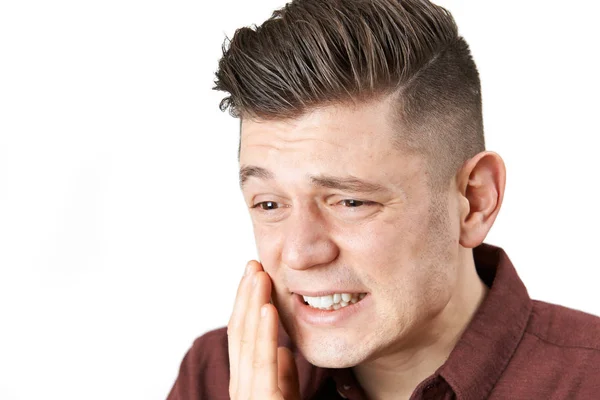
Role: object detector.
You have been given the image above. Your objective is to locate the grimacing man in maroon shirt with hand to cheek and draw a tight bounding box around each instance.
[169,0,600,400]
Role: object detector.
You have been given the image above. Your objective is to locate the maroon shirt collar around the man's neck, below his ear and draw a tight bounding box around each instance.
[437,244,532,400]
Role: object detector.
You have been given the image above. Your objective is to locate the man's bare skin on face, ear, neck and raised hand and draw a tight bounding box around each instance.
[228,92,505,399]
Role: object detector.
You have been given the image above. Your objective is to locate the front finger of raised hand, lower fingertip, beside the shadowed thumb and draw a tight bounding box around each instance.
[252,304,279,399]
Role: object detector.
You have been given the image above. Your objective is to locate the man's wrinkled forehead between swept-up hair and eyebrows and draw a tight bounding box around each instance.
[240,100,418,189]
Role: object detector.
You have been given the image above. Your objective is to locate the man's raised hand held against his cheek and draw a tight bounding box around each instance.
[227,261,300,400]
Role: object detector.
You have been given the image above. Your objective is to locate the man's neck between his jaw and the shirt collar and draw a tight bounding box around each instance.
[353,252,488,400]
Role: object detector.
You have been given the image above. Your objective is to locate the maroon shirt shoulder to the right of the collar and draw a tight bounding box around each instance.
[493,300,600,399]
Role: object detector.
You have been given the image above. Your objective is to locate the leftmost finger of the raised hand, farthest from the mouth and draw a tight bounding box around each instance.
[227,261,262,398]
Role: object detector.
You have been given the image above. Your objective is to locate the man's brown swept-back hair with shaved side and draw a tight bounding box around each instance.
[214,0,485,189]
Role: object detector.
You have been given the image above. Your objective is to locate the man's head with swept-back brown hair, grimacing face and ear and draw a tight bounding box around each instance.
[216,0,504,367]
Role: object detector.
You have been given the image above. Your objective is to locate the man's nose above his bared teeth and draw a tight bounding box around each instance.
[281,203,339,270]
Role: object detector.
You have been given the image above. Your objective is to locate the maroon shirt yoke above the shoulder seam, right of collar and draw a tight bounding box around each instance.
[525,300,600,354]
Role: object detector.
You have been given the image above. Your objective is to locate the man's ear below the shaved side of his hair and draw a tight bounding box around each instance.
[457,151,506,248]
